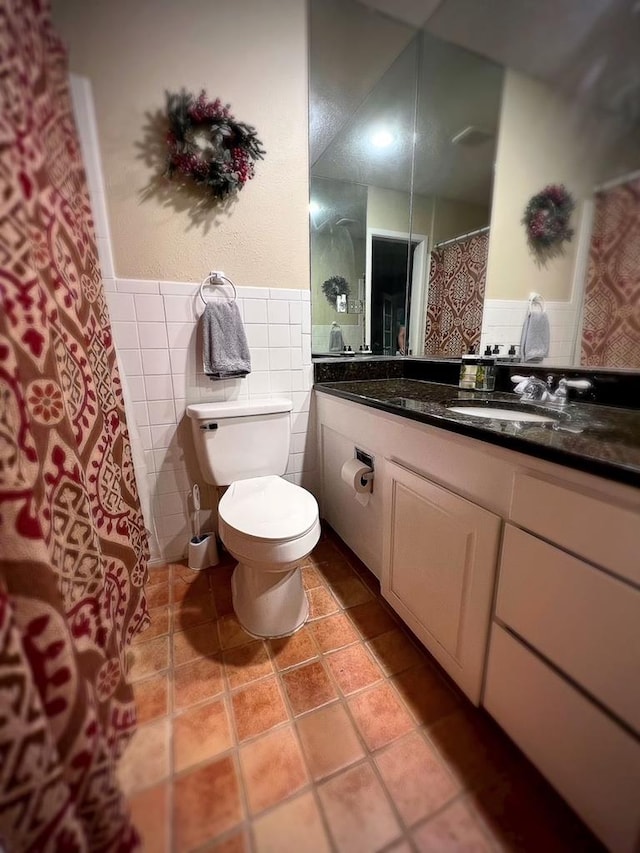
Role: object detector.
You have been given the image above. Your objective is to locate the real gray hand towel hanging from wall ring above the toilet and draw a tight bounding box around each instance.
[200,300,251,379]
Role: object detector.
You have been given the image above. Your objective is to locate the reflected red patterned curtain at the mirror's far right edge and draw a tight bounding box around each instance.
[580,178,640,368]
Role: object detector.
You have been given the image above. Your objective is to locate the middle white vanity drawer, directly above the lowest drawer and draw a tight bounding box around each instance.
[496,524,640,731]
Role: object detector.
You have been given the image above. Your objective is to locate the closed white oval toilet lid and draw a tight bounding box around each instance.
[218,476,318,540]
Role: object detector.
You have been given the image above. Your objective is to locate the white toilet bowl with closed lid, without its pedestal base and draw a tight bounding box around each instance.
[218,476,320,572]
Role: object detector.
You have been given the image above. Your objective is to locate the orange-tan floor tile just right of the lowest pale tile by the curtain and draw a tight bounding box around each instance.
[173,699,233,773]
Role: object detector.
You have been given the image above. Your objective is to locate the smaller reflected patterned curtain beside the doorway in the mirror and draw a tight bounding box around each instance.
[424,234,489,358]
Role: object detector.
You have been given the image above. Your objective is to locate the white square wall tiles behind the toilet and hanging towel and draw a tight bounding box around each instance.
[107,279,316,560]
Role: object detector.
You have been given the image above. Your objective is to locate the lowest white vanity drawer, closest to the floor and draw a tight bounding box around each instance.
[484,623,640,853]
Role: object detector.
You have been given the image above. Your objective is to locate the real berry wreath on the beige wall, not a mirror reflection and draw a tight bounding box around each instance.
[167,89,266,201]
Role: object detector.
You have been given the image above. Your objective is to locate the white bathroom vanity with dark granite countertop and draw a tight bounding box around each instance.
[315,379,640,851]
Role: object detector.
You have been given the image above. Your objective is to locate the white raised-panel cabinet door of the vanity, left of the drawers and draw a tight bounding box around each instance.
[382,463,501,705]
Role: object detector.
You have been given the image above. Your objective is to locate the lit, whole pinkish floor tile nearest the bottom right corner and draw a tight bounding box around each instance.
[375,732,460,826]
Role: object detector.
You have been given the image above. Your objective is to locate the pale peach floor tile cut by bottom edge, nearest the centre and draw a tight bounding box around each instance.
[253,793,331,853]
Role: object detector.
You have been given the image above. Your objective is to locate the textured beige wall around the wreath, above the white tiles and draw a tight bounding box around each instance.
[54,0,309,288]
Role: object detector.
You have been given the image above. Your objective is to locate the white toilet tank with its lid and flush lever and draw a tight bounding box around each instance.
[187,399,293,486]
